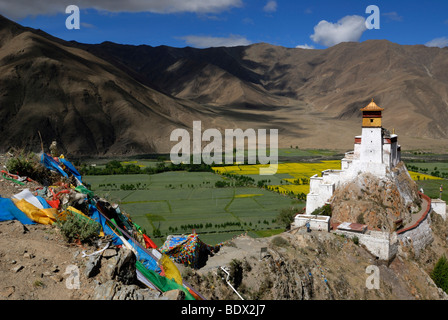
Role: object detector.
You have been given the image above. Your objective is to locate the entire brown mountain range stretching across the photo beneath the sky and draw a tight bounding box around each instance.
[0,18,448,155]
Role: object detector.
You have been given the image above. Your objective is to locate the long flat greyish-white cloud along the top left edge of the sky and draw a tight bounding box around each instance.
[0,0,243,19]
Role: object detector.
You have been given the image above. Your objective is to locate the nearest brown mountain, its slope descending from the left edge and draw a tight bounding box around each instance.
[0,18,238,155]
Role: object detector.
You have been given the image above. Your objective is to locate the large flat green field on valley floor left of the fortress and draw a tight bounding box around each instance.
[84,171,305,245]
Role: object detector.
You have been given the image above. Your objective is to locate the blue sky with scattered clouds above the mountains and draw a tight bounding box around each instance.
[0,0,448,49]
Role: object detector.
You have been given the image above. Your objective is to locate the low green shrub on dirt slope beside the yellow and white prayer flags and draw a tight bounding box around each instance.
[56,214,101,243]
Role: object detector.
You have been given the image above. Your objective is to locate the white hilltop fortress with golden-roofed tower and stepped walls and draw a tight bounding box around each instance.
[306,99,401,214]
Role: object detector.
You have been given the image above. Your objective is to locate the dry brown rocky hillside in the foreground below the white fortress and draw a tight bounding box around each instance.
[184,228,447,300]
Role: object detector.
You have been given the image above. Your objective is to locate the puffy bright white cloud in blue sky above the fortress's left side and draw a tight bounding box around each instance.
[310,16,367,47]
